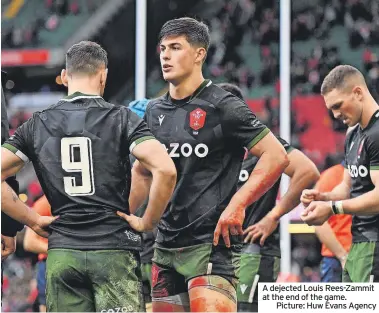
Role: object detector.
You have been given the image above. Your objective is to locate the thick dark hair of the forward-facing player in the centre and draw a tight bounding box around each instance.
[158,17,210,51]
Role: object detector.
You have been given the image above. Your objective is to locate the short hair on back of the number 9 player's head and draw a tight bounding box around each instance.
[66,41,108,75]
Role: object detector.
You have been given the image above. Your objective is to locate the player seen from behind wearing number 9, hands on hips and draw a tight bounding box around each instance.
[1,41,176,312]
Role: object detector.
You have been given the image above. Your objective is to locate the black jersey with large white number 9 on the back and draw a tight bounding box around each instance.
[3,93,154,250]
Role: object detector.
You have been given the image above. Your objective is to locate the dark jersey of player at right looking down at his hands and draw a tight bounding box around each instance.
[345,110,379,242]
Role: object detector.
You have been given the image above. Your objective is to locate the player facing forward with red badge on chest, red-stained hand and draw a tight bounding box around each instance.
[132,18,288,312]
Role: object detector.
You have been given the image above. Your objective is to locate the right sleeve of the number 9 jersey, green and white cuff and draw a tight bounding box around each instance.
[126,109,155,152]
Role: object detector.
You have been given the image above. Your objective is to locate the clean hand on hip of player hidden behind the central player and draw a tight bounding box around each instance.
[243,215,279,246]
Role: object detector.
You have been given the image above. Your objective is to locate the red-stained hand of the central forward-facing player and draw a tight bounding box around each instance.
[213,205,245,248]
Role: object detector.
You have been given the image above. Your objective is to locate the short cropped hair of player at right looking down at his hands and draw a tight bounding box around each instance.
[321,65,365,96]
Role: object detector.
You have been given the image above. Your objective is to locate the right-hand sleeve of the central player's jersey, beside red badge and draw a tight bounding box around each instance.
[221,95,270,150]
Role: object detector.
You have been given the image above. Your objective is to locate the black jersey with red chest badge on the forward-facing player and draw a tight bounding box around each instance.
[145,80,269,248]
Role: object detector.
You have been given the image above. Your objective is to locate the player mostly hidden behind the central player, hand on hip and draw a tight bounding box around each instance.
[218,83,320,312]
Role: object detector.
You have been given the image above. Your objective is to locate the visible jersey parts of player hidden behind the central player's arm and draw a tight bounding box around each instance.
[238,137,294,257]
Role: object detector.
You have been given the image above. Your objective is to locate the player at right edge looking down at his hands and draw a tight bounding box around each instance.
[301,65,379,282]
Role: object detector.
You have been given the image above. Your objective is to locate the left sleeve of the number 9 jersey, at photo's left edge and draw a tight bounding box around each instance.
[2,117,34,162]
